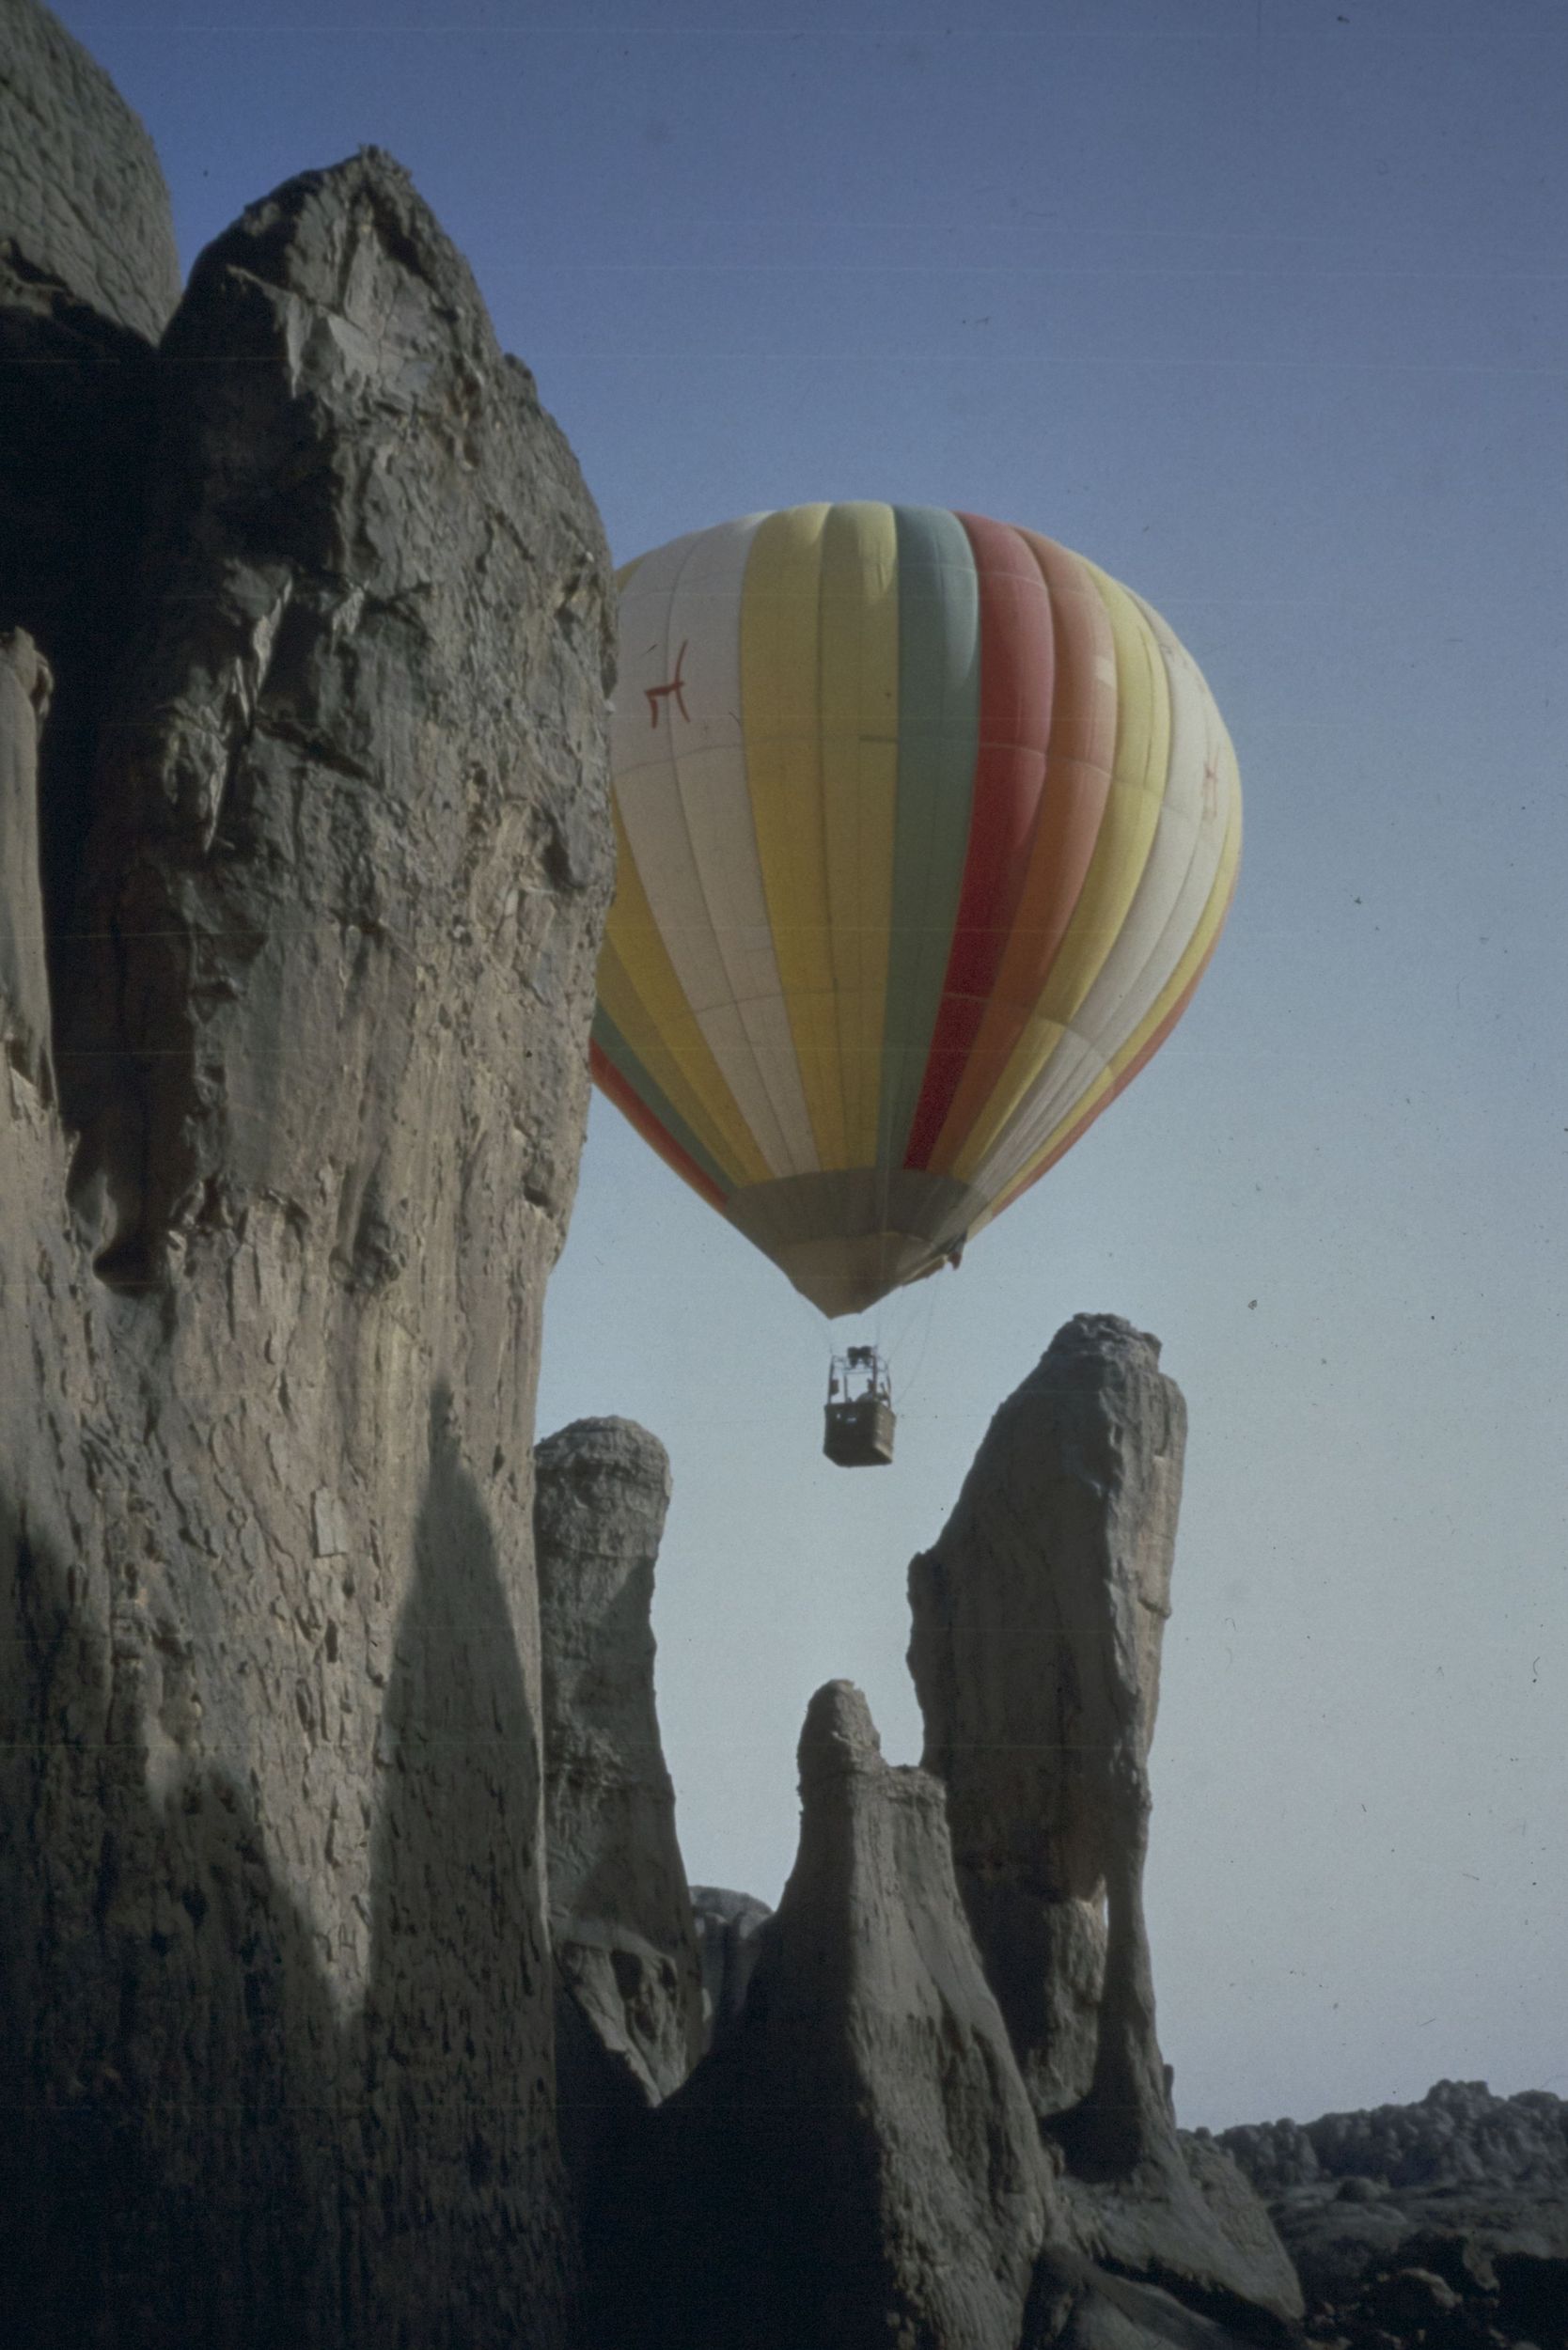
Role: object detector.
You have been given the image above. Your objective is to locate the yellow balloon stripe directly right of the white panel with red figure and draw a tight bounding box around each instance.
[741,506,851,1170]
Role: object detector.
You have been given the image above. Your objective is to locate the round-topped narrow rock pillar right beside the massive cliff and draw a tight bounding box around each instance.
[534,1419,703,2108]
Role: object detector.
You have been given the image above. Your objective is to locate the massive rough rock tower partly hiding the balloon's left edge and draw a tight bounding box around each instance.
[0,128,611,2350]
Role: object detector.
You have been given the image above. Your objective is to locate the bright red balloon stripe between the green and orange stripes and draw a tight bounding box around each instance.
[902,515,1053,1168]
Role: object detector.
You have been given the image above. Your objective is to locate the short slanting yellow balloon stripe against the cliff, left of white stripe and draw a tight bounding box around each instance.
[600,808,774,1184]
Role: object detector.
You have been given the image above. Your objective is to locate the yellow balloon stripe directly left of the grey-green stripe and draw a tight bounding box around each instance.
[818,506,898,1168]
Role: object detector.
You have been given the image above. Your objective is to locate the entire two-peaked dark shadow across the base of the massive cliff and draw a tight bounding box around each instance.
[0,1389,569,2350]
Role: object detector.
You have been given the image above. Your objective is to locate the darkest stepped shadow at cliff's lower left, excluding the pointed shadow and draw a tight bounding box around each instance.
[0,1495,341,2350]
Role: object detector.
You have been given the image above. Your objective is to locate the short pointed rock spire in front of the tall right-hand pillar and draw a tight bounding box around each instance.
[630,1683,1051,2350]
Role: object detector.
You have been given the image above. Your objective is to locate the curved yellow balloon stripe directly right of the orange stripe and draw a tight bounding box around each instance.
[954,557,1170,1183]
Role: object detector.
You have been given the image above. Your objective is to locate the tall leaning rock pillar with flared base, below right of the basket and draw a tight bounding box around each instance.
[910,1314,1300,2329]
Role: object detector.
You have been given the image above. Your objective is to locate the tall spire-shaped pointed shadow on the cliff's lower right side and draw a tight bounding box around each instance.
[362,1382,567,2343]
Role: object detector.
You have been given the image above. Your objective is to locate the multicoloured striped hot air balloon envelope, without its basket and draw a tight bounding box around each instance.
[592,503,1241,1354]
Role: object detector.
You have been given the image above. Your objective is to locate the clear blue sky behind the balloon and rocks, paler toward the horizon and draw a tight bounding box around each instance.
[61,0,1568,2127]
